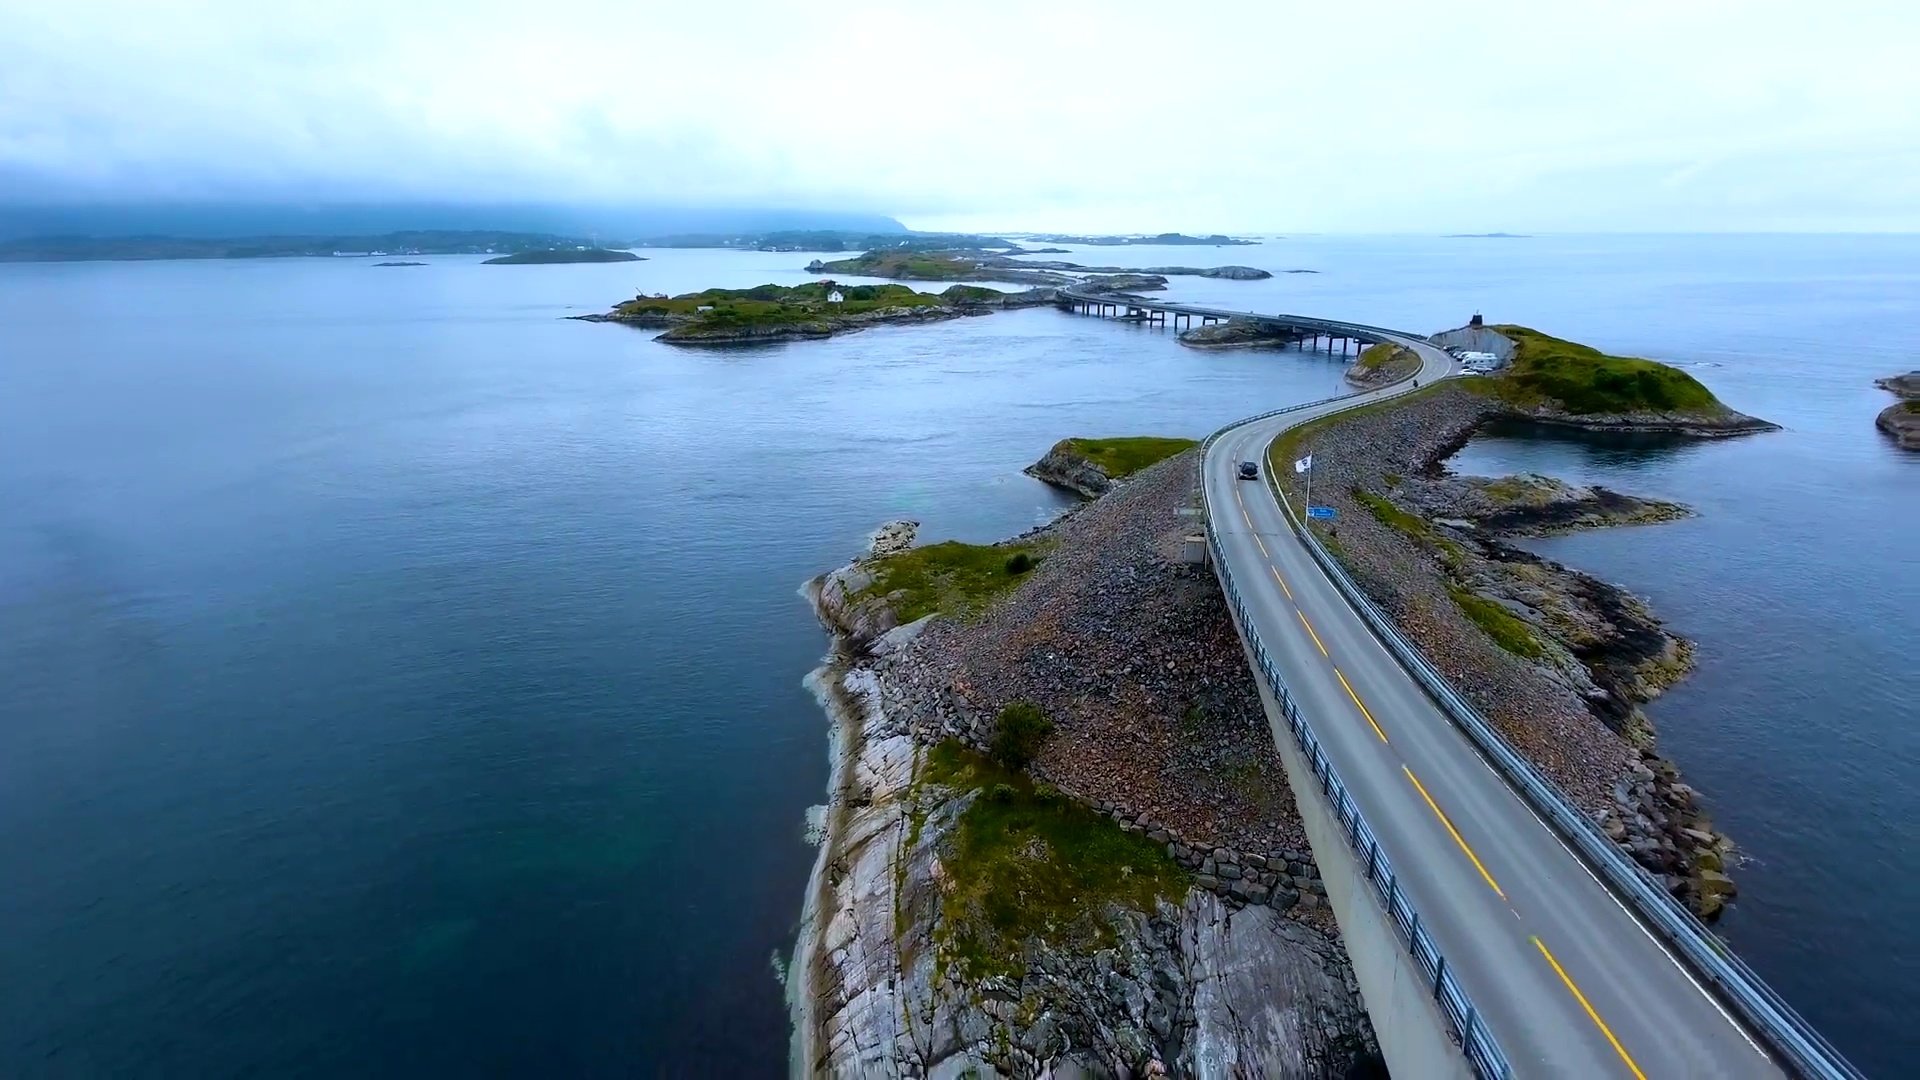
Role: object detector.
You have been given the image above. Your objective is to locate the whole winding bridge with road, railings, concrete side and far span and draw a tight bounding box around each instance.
[1062,290,1860,1080]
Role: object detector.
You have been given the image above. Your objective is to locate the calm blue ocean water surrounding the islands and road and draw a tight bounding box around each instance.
[0,236,1920,1078]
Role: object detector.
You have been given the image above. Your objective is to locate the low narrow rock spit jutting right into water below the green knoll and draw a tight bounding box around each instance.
[1394,473,1693,536]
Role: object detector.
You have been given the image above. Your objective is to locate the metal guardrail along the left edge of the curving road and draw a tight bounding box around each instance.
[1200,398,1513,1080]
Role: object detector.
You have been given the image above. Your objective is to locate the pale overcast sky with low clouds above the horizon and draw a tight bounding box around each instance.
[0,0,1920,233]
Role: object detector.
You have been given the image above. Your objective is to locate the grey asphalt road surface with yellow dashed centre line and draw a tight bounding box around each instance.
[1204,338,1782,1080]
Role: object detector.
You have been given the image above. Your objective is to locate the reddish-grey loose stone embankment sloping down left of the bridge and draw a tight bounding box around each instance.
[864,452,1308,861]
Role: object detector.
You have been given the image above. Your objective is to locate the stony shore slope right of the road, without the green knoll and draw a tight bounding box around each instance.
[1281,382,1732,915]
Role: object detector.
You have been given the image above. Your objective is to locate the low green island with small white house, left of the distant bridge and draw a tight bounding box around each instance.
[572,281,1054,346]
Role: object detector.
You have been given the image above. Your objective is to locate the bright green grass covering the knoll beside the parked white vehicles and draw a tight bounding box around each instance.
[1490,325,1728,415]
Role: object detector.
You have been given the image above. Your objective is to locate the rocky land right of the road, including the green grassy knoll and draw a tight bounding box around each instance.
[1269,327,1774,917]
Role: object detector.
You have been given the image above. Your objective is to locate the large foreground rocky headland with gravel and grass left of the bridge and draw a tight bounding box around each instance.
[789,440,1379,1080]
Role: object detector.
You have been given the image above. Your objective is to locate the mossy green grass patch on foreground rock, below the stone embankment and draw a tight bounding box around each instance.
[924,742,1187,980]
